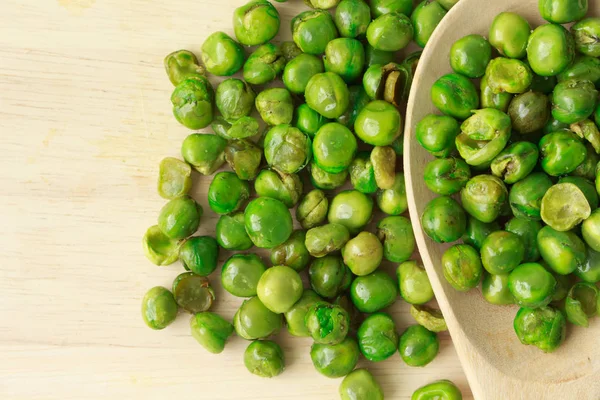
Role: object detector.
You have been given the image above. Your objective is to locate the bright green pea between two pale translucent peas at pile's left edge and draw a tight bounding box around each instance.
[158,195,203,239]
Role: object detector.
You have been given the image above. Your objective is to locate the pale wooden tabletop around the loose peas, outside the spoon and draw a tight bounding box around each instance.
[0,0,471,400]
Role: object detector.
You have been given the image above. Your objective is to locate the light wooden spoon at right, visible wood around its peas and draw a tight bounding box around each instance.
[404,0,600,400]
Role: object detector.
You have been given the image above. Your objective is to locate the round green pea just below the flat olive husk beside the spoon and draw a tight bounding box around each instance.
[398,325,440,367]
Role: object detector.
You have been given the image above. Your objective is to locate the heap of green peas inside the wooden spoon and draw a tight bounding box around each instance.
[415,0,600,352]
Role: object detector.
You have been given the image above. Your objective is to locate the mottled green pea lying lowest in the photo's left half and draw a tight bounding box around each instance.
[244,340,285,378]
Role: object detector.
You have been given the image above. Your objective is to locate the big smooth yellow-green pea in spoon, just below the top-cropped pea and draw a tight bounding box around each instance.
[527,24,575,76]
